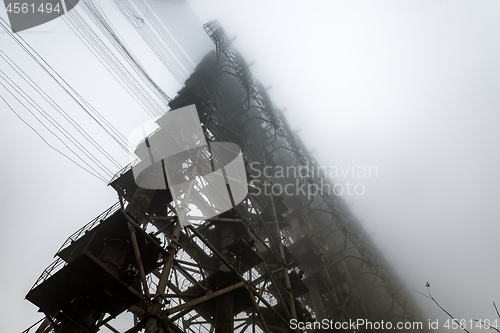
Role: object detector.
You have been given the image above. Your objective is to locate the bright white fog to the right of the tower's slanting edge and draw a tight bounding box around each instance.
[188,1,500,320]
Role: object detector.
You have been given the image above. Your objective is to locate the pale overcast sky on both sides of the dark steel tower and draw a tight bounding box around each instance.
[0,0,500,333]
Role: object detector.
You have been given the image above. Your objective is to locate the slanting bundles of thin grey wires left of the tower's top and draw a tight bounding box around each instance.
[0,0,213,182]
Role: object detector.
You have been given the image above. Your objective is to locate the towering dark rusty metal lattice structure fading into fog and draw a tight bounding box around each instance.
[25,21,425,333]
